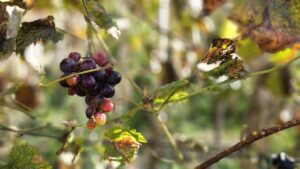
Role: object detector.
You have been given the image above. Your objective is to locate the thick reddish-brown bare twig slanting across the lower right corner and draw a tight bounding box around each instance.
[195,119,300,169]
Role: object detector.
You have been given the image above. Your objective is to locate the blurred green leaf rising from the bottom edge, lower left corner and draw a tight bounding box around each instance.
[8,144,52,169]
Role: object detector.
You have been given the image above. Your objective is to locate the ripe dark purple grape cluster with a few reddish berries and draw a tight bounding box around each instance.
[60,52,121,130]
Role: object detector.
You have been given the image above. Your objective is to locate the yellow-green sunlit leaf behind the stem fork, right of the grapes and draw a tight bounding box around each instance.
[153,79,190,109]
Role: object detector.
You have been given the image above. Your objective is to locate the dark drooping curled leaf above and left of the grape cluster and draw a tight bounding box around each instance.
[16,16,63,53]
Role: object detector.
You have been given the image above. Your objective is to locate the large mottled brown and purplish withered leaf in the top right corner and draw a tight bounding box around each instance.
[230,0,300,53]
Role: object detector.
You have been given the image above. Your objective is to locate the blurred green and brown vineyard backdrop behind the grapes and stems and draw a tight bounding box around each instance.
[0,0,300,169]
